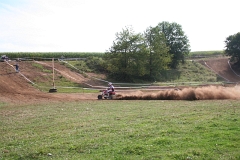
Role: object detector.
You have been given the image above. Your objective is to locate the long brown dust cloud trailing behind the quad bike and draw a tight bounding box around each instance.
[116,86,240,100]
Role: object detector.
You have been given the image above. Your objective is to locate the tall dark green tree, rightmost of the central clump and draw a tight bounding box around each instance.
[157,22,190,68]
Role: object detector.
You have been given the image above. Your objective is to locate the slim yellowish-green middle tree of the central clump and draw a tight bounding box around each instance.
[144,27,171,79]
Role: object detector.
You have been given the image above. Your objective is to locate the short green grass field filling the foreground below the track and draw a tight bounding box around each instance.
[0,100,240,160]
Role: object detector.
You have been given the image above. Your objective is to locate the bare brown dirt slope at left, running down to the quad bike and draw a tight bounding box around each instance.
[0,61,97,105]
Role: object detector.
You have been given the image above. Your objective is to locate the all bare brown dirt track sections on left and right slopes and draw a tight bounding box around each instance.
[0,58,240,104]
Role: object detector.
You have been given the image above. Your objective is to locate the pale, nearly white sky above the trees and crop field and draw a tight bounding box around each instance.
[0,0,240,52]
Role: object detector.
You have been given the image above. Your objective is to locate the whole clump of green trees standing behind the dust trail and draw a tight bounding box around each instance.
[104,22,190,81]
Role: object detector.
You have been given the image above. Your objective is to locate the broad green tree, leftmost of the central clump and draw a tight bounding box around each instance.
[105,27,146,81]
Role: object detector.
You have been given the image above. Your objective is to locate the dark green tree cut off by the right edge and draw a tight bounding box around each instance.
[224,32,240,65]
